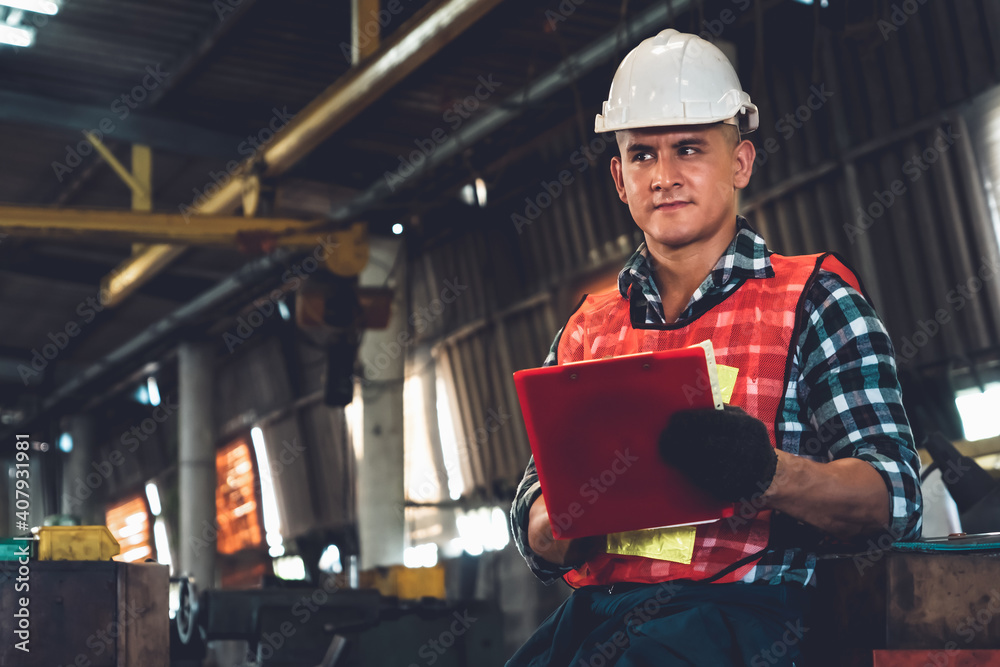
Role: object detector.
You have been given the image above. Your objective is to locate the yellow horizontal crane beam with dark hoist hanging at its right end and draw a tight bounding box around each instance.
[0,135,392,405]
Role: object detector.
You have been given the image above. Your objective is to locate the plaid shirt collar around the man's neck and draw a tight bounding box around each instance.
[618,215,774,297]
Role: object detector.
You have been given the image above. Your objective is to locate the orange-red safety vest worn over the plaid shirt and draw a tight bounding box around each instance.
[558,253,861,587]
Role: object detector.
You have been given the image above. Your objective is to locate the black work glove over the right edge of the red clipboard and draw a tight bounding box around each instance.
[660,405,778,502]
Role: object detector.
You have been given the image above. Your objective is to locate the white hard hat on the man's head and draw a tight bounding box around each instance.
[594,29,757,133]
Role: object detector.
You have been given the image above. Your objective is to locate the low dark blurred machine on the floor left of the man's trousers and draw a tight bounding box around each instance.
[170,578,503,667]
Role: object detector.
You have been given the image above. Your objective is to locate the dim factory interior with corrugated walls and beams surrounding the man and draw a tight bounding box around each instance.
[0,0,1000,667]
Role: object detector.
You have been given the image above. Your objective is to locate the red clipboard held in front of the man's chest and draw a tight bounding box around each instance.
[514,341,735,539]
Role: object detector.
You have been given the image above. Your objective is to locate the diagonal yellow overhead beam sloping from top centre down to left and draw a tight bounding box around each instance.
[105,0,501,304]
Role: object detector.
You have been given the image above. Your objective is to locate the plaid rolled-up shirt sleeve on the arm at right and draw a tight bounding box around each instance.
[798,272,922,541]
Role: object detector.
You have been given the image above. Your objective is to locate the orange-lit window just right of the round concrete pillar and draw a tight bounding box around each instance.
[215,438,261,554]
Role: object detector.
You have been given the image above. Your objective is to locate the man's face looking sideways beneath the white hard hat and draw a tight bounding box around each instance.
[611,124,755,251]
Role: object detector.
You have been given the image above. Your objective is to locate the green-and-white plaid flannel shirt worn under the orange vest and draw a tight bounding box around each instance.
[511,217,921,584]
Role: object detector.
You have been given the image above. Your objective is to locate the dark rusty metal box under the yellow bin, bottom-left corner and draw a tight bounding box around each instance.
[0,561,169,667]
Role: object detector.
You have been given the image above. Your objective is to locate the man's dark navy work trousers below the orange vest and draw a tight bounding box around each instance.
[507,581,809,667]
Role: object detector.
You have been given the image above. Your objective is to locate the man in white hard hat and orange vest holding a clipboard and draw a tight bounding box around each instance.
[508,30,921,667]
